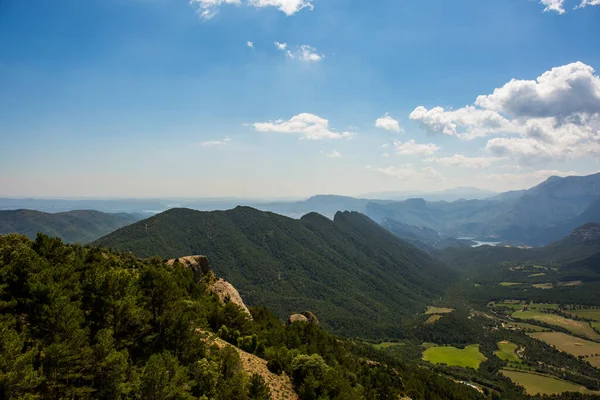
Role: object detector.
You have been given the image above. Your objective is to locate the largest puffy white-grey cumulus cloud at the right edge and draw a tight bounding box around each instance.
[410,62,600,165]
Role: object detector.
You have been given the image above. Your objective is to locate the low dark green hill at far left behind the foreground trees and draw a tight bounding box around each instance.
[0,210,140,244]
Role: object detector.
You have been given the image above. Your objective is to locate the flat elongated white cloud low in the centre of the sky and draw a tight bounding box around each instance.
[252,113,354,140]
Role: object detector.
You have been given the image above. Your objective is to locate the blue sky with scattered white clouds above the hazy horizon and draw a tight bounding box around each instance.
[0,0,600,198]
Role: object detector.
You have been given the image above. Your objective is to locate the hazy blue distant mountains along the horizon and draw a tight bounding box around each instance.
[0,174,600,250]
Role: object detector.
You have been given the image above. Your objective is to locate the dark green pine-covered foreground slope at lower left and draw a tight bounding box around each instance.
[0,234,483,400]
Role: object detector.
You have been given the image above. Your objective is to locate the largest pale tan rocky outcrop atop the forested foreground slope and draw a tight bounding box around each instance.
[167,256,252,319]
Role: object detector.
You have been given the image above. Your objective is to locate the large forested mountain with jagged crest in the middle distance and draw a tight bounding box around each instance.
[95,207,453,337]
